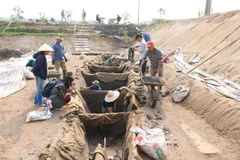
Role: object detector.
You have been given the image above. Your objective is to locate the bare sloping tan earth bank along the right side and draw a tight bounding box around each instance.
[149,11,240,138]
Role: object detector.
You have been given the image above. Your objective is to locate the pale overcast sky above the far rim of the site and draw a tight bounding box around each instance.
[0,0,240,23]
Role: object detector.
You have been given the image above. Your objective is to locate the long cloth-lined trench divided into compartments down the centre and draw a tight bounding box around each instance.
[39,53,152,160]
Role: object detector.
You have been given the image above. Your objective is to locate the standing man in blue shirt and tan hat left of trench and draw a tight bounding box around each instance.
[52,35,67,79]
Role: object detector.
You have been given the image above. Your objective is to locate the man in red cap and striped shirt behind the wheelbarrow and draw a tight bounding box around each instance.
[139,41,163,90]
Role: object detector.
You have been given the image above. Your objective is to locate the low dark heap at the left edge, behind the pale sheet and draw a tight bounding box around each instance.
[0,49,23,61]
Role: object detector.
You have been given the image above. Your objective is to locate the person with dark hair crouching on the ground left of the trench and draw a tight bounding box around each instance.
[43,76,74,109]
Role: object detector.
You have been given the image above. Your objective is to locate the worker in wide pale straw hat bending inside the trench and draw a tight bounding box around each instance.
[102,87,130,113]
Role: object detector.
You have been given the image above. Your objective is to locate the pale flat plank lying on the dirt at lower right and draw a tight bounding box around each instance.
[181,124,221,155]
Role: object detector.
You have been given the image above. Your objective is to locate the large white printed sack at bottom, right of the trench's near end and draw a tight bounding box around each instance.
[130,127,167,160]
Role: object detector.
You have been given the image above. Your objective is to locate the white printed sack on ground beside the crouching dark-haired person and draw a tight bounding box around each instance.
[26,100,53,123]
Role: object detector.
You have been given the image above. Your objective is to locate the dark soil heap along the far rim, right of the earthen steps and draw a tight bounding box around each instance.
[93,25,141,37]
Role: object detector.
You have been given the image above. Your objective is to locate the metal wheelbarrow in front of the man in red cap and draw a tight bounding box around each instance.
[141,76,166,108]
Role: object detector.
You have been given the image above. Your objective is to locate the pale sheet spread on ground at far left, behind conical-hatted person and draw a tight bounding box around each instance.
[0,55,52,99]
